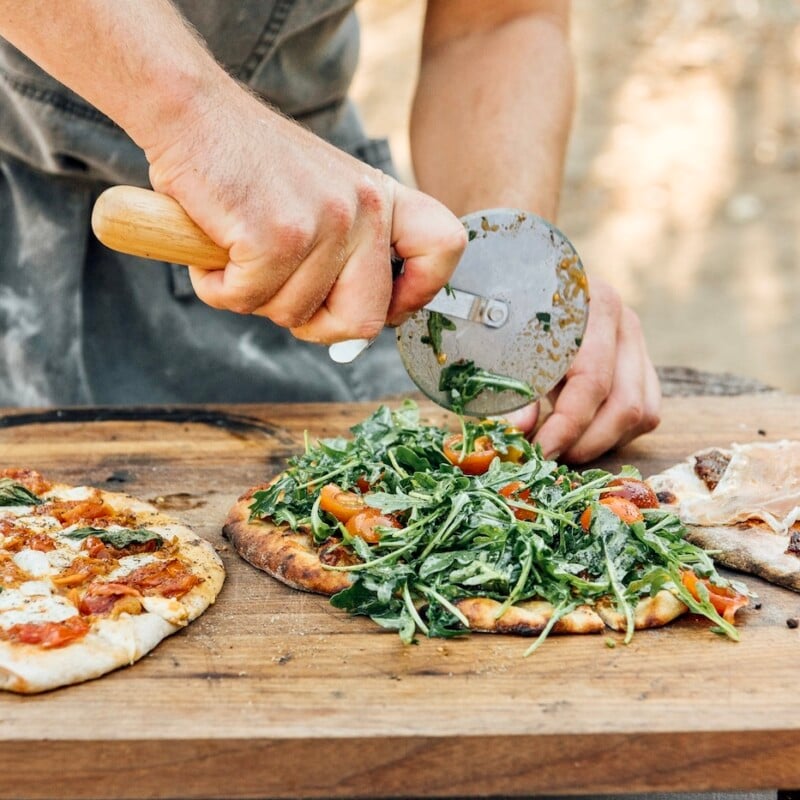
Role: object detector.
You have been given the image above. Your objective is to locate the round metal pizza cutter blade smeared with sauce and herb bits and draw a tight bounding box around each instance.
[397,208,589,416]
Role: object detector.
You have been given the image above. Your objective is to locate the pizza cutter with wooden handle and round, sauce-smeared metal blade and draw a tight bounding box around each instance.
[92,186,589,416]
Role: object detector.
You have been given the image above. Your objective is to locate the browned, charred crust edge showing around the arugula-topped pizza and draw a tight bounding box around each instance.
[223,478,688,636]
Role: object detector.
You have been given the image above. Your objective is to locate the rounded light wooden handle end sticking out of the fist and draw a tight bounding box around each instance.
[92,186,228,269]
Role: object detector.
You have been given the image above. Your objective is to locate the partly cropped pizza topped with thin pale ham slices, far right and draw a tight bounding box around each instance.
[648,441,800,591]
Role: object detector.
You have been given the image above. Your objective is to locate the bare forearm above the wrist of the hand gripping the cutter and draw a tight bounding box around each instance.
[0,0,230,148]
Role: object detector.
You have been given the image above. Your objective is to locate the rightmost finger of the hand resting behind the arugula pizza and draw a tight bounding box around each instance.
[562,309,661,463]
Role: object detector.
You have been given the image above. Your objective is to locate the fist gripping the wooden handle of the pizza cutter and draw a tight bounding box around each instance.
[145,82,466,343]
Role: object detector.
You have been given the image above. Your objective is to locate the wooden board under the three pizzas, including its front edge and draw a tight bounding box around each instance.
[0,393,800,798]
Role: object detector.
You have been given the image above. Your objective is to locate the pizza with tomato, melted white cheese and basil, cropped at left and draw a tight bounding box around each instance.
[0,469,224,693]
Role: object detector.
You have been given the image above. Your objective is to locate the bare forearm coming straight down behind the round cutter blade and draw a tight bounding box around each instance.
[411,1,573,219]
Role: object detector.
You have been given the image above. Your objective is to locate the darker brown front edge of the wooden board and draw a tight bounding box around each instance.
[0,730,800,800]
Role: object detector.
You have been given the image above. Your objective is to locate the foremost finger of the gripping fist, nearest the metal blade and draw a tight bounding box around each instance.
[388,184,467,325]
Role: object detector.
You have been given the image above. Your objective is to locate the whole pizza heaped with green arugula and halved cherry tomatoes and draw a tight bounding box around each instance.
[224,401,749,652]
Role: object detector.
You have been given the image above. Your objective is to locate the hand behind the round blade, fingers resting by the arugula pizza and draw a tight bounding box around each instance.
[509,279,661,464]
